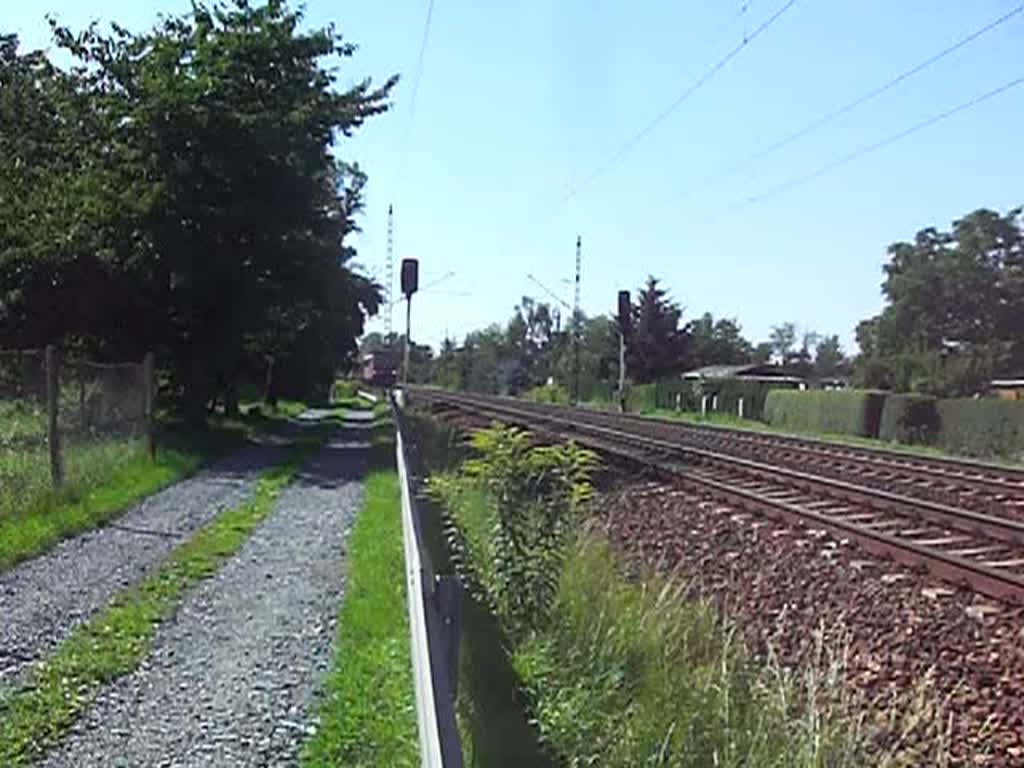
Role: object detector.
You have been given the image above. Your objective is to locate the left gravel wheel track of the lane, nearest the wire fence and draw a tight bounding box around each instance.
[0,444,282,689]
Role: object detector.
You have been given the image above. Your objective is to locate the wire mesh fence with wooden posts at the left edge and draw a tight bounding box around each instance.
[0,347,154,515]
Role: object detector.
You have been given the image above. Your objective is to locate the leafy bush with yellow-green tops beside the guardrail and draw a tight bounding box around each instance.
[429,424,597,640]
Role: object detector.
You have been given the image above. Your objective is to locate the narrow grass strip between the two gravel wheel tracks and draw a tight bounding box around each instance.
[0,440,318,766]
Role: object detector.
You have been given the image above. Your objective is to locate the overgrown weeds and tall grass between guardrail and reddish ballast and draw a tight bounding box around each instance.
[421,426,880,768]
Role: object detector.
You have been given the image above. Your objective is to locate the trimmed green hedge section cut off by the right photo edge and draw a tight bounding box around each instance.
[937,397,1024,459]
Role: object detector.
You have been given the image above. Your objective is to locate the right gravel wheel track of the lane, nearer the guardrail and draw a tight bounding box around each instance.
[42,421,366,768]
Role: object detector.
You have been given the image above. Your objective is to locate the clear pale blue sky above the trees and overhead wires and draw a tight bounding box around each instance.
[8,0,1024,349]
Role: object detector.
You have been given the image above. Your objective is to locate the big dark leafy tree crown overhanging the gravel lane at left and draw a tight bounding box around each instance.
[0,0,395,414]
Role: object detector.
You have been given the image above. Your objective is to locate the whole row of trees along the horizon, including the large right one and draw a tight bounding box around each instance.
[361,208,1024,399]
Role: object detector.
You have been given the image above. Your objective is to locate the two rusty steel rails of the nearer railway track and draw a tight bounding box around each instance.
[415,389,1024,601]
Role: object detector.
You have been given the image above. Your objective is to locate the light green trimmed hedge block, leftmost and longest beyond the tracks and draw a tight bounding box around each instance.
[764,389,886,437]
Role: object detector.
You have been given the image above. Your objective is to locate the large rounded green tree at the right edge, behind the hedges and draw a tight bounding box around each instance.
[857,208,1024,396]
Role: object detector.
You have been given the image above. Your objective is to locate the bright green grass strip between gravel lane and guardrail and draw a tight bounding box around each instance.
[302,438,420,768]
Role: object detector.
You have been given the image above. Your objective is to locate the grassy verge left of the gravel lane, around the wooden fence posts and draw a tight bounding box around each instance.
[0,399,307,571]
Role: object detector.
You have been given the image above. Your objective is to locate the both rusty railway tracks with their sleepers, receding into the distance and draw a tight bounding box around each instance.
[412,388,1024,602]
